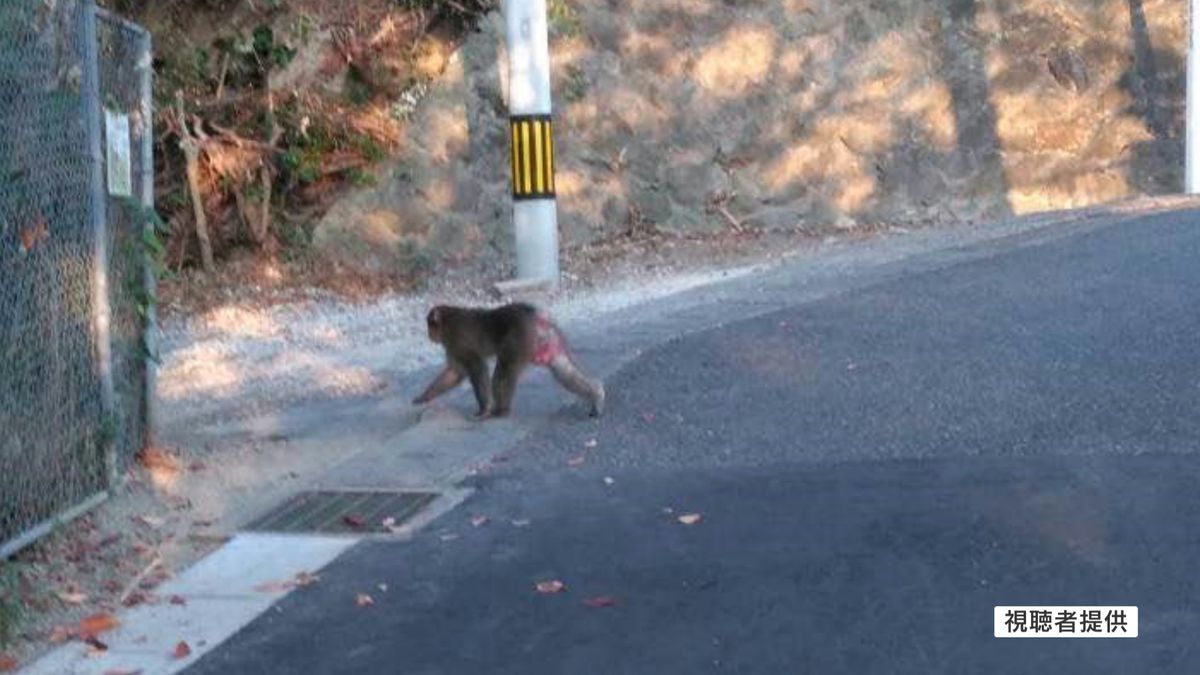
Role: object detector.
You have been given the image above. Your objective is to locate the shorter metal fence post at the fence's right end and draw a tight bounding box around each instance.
[138,30,158,448]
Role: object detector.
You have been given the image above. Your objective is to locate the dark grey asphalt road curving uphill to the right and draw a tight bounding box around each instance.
[188,214,1200,675]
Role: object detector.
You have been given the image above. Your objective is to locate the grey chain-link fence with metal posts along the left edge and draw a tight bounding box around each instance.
[0,0,152,557]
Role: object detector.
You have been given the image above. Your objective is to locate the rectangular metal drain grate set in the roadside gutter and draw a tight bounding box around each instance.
[245,490,438,534]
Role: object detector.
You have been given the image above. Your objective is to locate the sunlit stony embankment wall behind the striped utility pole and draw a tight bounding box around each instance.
[314,0,1186,275]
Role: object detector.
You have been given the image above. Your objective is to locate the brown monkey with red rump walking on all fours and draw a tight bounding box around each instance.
[413,303,605,419]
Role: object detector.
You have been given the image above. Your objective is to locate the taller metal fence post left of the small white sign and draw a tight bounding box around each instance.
[79,0,118,488]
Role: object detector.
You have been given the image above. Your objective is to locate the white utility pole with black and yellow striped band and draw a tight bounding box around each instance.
[504,0,558,283]
